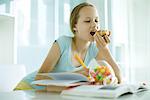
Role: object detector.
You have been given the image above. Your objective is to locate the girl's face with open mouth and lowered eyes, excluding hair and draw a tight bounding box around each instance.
[75,6,99,41]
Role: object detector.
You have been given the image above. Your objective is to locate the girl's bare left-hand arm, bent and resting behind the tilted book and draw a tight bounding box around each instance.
[35,42,60,80]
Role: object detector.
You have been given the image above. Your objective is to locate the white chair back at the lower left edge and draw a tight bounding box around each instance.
[0,64,26,92]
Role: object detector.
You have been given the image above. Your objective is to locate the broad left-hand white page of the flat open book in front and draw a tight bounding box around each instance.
[61,85,124,98]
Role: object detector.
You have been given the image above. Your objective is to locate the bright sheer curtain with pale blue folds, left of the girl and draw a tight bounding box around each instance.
[14,0,86,73]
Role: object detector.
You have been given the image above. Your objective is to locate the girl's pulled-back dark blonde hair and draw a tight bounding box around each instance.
[70,2,94,34]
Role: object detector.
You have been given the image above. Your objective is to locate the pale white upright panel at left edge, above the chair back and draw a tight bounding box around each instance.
[0,14,14,64]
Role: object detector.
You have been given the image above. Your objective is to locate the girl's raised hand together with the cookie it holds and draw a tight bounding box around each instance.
[94,30,111,48]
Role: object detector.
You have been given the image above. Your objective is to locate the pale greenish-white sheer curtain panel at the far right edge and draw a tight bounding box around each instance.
[128,0,150,82]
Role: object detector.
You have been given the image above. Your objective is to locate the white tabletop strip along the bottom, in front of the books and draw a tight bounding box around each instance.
[0,90,150,100]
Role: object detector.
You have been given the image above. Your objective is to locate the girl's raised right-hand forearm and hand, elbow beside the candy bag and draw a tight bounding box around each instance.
[94,33,121,83]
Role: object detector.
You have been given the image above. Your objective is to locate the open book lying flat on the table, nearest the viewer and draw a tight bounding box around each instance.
[61,84,148,98]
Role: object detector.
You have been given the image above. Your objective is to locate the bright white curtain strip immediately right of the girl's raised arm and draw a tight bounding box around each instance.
[109,0,130,82]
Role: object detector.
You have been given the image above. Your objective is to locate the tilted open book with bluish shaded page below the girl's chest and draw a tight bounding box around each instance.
[31,72,89,92]
